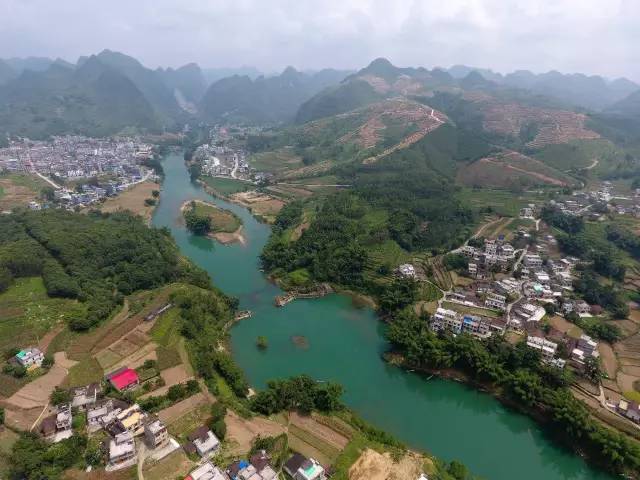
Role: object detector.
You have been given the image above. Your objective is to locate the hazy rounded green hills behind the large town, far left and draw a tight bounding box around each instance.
[0,57,161,139]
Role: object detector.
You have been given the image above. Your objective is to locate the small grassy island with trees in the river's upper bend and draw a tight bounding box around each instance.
[181,200,246,245]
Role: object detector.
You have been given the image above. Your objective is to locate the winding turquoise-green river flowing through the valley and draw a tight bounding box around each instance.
[153,154,613,480]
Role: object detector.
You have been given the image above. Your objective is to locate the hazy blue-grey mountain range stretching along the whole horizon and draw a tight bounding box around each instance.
[0,50,640,138]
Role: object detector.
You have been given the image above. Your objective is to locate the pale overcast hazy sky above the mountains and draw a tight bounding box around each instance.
[0,0,640,80]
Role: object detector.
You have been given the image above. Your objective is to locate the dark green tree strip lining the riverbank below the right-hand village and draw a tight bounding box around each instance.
[388,312,640,473]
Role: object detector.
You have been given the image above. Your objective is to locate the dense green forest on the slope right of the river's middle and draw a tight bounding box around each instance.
[261,127,476,294]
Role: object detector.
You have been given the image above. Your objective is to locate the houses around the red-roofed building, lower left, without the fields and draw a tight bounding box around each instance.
[3,348,326,480]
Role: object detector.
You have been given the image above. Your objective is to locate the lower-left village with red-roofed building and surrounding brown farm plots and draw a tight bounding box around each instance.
[2,286,360,480]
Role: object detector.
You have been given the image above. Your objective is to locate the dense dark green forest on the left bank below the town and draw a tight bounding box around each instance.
[0,210,209,330]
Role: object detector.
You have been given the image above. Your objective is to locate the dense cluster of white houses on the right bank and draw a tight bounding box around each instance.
[430,228,602,376]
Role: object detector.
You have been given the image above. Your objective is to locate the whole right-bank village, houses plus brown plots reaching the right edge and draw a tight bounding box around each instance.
[395,181,640,429]
